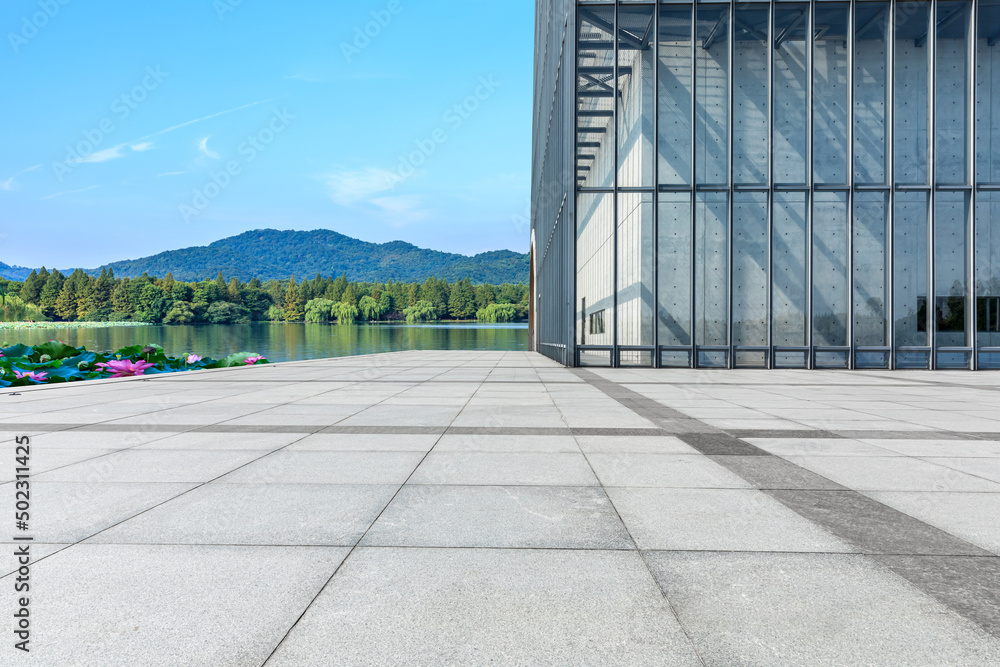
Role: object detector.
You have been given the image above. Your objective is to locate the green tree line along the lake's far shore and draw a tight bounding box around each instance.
[0,267,528,324]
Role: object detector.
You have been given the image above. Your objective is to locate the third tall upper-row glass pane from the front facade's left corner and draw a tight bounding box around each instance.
[659,5,691,185]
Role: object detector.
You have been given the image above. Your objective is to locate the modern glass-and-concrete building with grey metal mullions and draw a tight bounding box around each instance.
[532,0,1000,369]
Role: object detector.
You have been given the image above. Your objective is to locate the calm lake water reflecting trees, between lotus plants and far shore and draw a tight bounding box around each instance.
[0,323,528,361]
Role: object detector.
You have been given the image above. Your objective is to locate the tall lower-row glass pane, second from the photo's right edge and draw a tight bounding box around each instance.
[934,192,969,347]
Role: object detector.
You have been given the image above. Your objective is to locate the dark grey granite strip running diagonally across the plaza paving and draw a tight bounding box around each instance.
[574,370,1000,637]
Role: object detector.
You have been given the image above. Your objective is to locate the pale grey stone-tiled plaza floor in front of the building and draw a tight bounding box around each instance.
[0,352,1000,667]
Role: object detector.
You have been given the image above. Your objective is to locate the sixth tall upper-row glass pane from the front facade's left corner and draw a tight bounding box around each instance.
[774,3,809,185]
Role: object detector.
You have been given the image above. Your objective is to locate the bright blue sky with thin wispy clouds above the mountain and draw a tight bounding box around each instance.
[0,0,534,268]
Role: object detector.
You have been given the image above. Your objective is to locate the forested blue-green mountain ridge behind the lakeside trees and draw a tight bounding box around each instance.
[0,229,529,284]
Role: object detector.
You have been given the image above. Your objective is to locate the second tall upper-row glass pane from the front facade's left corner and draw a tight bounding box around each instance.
[618,6,656,187]
